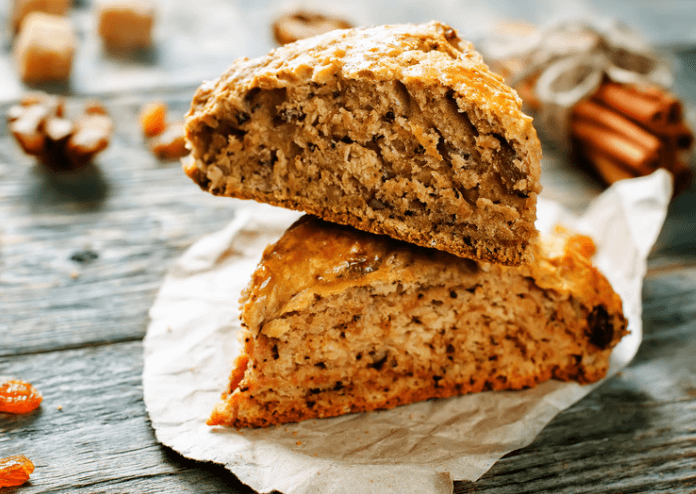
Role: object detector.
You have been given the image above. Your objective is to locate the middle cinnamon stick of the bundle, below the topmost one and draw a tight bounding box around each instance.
[571,119,659,175]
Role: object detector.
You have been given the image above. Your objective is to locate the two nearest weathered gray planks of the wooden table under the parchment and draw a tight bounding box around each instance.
[0,41,696,493]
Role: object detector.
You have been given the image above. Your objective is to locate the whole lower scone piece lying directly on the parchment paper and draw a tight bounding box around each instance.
[208,216,627,427]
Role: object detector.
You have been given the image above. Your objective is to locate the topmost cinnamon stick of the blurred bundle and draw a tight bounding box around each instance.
[593,82,681,128]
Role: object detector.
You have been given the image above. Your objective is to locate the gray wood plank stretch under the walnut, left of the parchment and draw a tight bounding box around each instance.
[0,91,245,355]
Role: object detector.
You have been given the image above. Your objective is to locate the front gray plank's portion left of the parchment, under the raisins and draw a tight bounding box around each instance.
[0,342,252,494]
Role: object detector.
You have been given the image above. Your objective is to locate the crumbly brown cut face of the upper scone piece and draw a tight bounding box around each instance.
[189,72,538,264]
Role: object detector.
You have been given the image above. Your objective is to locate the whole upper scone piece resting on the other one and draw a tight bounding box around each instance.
[184,22,541,265]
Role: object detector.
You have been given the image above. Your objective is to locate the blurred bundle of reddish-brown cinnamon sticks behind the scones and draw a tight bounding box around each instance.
[570,81,694,194]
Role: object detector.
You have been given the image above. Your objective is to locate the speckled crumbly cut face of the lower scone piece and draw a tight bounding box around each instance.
[211,262,625,426]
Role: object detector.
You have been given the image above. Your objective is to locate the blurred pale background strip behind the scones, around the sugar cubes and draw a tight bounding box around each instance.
[0,0,696,101]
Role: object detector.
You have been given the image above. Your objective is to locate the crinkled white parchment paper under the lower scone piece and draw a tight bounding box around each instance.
[143,171,671,494]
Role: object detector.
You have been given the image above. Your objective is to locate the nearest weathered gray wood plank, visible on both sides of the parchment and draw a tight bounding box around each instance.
[0,268,696,493]
